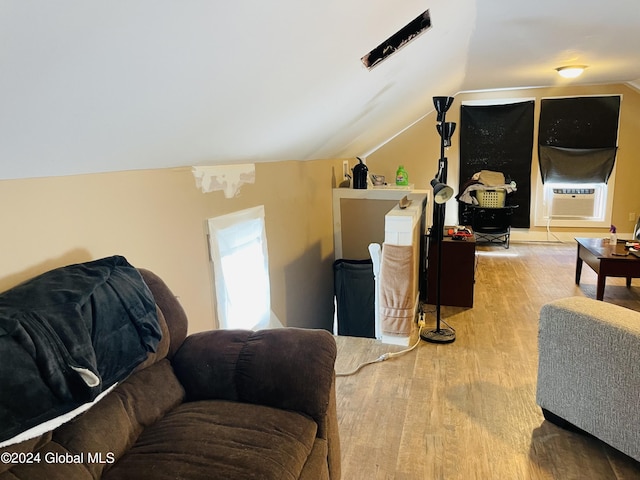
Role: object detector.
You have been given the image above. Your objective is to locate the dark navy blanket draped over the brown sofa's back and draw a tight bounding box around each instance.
[0,256,162,442]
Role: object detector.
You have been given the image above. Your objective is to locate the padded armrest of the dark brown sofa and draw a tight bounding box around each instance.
[172,328,337,422]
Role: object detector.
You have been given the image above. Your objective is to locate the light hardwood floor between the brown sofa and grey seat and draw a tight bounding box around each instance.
[336,243,640,480]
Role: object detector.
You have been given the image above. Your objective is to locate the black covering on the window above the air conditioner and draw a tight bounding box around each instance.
[538,96,620,183]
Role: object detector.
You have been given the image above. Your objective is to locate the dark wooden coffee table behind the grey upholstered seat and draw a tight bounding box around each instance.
[575,238,640,300]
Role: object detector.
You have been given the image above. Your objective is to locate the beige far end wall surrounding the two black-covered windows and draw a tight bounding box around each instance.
[367,85,640,238]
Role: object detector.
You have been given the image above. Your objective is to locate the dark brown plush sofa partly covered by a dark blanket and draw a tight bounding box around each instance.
[0,262,340,480]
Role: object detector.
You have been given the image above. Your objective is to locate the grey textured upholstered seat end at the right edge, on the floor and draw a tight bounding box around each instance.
[536,297,640,460]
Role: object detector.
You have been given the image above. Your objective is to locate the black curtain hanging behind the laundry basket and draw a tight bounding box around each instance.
[459,101,534,228]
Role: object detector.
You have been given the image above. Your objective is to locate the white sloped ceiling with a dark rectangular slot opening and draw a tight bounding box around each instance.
[0,0,640,179]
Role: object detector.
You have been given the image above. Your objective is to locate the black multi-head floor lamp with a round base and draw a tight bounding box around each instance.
[420,97,456,343]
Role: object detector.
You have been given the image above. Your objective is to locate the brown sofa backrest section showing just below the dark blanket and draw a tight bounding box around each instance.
[0,359,184,480]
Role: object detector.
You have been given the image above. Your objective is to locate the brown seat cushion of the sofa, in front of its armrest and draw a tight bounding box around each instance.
[104,400,317,480]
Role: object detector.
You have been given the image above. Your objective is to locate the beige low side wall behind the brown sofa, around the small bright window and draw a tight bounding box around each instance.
[0,160,342,332]
